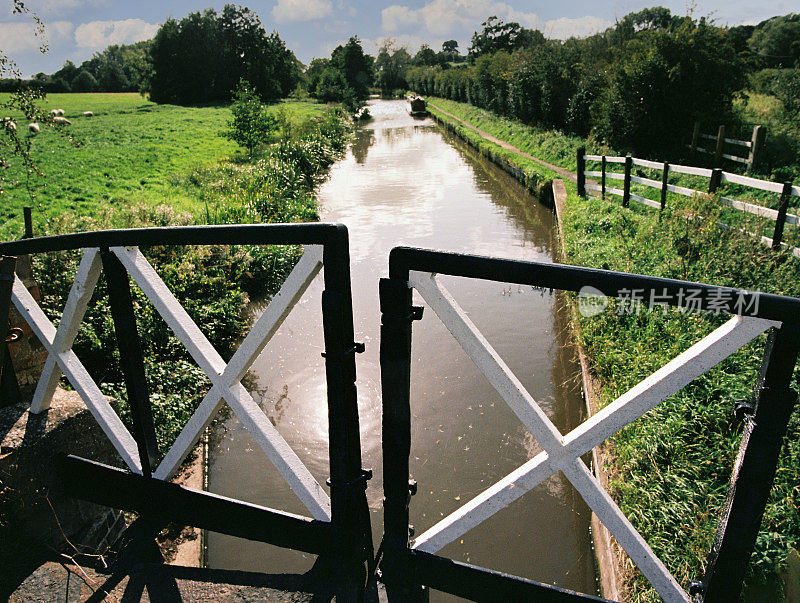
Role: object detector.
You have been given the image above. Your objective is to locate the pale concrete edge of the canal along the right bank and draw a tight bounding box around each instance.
[553,179,621,601]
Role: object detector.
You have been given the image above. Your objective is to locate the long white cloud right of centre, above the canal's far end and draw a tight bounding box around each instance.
[381,0,611,39]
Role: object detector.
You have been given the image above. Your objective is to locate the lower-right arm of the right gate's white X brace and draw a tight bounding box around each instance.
[561,459,689,603]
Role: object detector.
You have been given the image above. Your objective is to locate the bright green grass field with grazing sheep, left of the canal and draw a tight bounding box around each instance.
[0,93,325,239]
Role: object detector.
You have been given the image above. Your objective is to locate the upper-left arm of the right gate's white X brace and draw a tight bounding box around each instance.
[408,271,562,456]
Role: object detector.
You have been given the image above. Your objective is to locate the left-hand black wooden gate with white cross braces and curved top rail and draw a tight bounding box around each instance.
[0,224,373,592]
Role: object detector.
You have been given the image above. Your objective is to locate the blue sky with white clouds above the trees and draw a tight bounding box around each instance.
[0,0,800,76]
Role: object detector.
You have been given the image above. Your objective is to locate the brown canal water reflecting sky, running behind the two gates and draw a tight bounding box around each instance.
[208,101,596,594]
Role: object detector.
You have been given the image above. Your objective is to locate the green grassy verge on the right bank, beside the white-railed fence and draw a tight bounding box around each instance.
[433,99,800,601]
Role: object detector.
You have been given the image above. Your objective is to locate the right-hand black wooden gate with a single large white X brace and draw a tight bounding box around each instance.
[380,247,800,602]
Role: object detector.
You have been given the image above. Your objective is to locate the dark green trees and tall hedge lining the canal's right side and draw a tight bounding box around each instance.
[404,7,800,153]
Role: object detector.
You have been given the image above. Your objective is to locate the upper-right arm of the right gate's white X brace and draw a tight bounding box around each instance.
[564,316,781,458]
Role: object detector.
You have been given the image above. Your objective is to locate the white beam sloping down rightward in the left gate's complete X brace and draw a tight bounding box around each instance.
[111,247,330,520]
